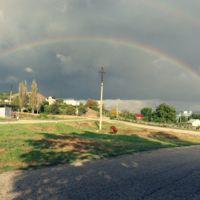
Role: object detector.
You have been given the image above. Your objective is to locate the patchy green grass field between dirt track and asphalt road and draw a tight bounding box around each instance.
[0,121,200,172]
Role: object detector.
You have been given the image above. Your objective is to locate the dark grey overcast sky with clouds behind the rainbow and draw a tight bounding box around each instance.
[0,0,200,112]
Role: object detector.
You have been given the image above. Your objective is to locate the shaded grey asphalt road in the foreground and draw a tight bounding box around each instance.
[0,146,200,200]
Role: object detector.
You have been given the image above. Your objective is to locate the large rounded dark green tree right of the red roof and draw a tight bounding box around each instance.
[152,103,176,123]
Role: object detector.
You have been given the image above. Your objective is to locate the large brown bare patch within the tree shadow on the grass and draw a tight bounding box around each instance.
[34,135,102,151]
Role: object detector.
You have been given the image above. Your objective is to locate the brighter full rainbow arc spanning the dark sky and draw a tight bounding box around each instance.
[0,37,200,81]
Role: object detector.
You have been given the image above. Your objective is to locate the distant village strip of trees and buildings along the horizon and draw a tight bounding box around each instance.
[0,80,200,127]
